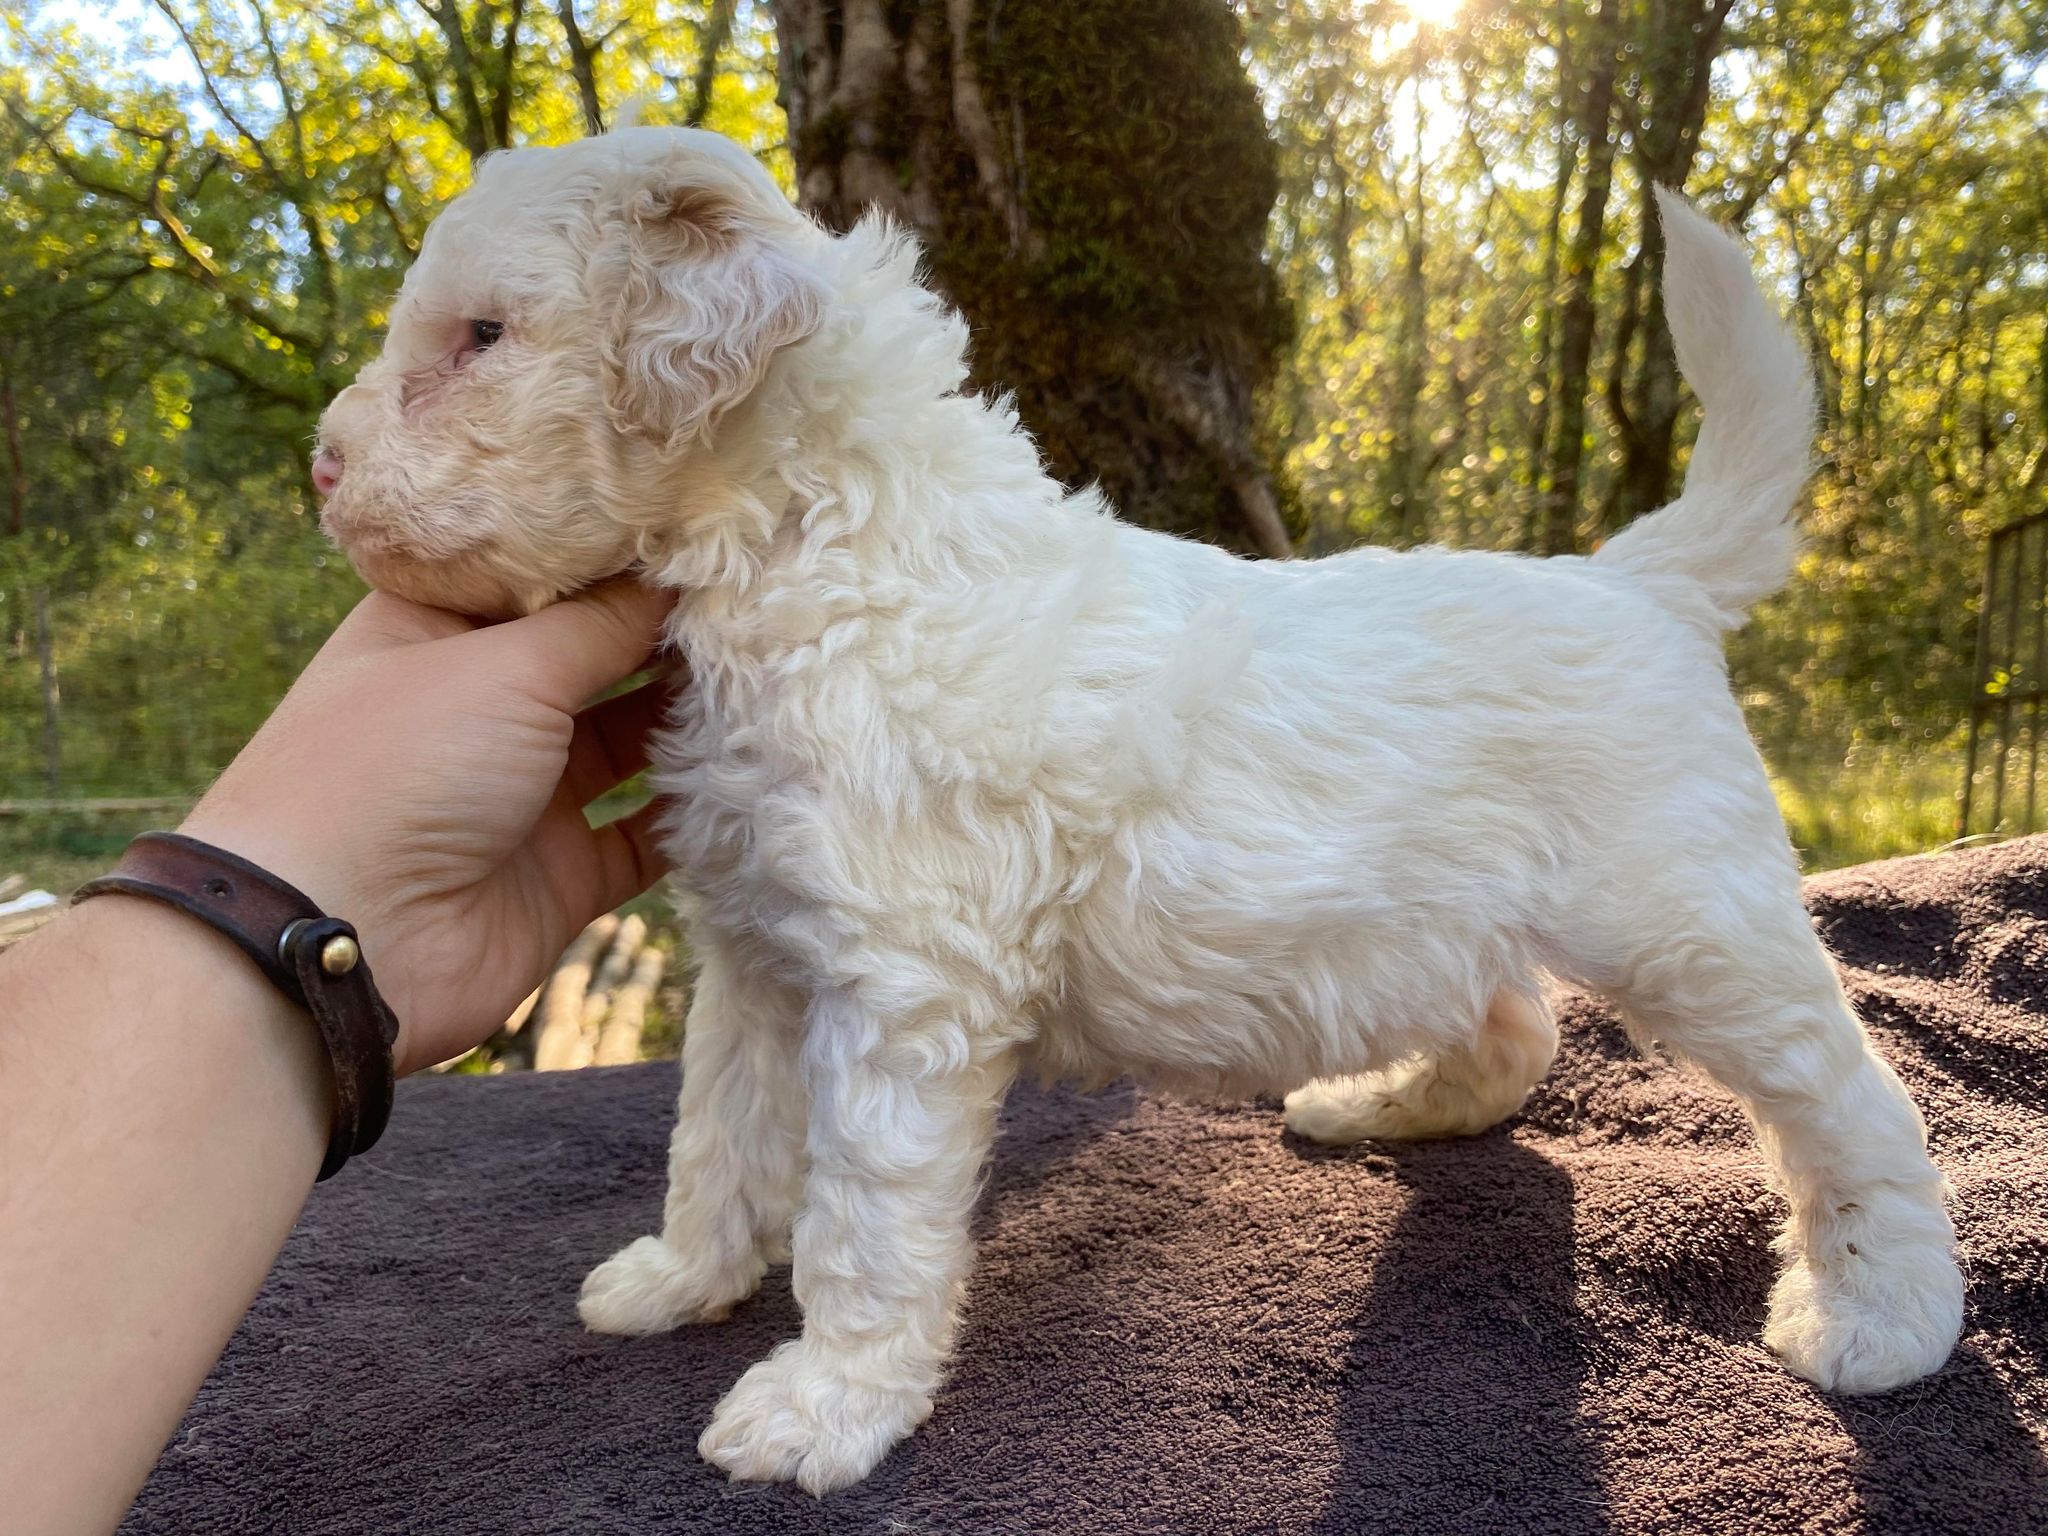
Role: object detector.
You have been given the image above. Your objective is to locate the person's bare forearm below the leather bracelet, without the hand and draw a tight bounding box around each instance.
[0,897,330,1532]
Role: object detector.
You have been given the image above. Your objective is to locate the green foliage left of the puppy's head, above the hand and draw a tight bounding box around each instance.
[0,0,786,799]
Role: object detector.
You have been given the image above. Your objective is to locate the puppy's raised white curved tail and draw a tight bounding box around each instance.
[1593,186,1815,629]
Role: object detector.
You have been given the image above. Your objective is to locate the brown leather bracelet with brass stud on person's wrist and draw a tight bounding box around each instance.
[72,831,397,1180]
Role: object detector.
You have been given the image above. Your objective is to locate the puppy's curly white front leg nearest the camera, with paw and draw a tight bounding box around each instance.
[696,989,1016,1493]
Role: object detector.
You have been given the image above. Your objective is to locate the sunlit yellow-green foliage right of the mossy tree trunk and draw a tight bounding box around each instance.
[1251,0,2048,786]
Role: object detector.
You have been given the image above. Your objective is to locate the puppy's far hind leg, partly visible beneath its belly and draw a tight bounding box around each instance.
[1286,989,1556,1147]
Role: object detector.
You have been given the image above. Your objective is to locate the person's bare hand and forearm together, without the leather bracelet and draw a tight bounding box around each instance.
[0,586,668,1534]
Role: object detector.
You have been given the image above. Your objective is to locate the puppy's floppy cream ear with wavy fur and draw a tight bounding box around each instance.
[604,182,825,446]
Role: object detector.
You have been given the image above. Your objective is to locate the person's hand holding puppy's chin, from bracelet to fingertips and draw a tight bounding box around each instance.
[182,582,678,1073]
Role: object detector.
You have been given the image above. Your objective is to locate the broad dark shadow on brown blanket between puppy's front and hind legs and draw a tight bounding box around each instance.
[1296,1130,1608,1536]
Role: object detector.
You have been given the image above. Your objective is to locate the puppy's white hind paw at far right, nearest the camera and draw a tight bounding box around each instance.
[1763,1241,1962,1393]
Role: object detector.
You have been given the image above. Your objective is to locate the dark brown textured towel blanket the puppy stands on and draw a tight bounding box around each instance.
[119,840,2048,1536]
